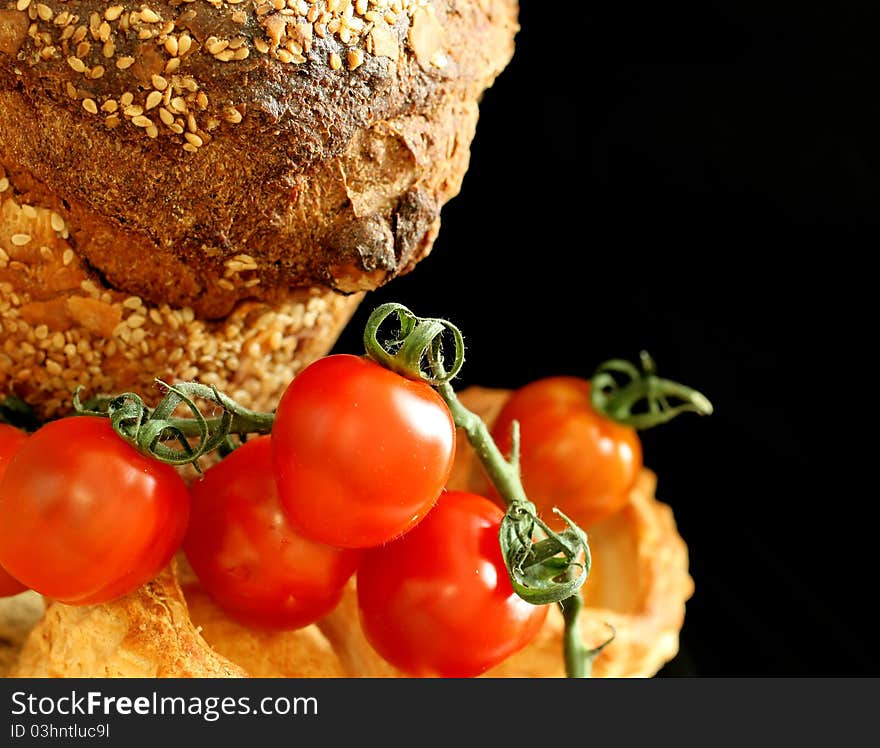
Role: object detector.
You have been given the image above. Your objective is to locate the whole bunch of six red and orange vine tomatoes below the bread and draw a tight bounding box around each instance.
[0,355,641,676]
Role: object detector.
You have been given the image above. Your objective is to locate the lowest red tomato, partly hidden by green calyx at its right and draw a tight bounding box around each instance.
[357,491,547,677]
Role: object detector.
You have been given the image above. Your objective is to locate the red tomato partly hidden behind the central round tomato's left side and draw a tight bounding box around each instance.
[184,436,360,629]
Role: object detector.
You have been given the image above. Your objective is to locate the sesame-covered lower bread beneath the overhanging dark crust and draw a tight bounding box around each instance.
[0,168,360,416]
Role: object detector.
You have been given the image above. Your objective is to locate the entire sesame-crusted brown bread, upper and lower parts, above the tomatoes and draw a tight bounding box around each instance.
[0,0,517,416]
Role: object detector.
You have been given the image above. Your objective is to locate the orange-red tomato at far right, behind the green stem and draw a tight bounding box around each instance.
[492,377,642,529]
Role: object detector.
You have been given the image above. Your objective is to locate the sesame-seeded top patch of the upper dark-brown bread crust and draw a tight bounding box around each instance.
[6,0,447,153]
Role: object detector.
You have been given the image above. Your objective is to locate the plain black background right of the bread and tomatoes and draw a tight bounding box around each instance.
[338,0,880,676]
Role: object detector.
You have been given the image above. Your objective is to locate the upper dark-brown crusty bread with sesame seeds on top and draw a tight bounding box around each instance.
[0,0,517,318]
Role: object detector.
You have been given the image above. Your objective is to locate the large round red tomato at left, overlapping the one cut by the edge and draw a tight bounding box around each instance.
[0,416,189,605]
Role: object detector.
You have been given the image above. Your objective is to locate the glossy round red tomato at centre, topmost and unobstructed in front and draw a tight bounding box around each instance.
[272,355,455,548]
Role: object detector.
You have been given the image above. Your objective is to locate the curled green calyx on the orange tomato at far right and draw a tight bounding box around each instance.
[590,351,714,430]
